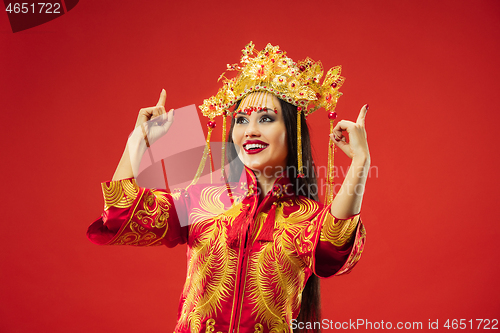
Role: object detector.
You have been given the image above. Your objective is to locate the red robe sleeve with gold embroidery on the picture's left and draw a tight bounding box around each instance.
[87,178,188,247]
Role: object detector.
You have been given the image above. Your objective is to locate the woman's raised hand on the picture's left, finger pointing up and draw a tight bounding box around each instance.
[135,89,174,146]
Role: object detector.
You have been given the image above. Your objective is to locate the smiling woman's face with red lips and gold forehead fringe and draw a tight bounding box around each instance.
[233,92,288,176]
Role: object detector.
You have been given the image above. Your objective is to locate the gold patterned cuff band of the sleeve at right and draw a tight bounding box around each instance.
[320,212,359,246]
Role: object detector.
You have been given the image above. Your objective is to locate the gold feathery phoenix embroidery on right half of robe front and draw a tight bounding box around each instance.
[248,198,319,332]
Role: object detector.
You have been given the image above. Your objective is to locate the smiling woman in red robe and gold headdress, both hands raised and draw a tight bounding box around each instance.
[88,45,370,333]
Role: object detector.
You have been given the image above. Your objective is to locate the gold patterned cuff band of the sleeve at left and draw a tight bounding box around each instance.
[101,179,139,210]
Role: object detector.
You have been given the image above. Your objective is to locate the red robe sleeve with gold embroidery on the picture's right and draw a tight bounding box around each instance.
[295,205,366,277]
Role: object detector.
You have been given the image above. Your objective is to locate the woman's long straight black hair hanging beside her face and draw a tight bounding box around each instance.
[227,95,321,333]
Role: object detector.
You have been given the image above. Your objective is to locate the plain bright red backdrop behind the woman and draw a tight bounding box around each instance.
[0,0,500,332]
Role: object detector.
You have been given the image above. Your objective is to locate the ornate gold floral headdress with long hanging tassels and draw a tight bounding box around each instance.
[194,42,344,202]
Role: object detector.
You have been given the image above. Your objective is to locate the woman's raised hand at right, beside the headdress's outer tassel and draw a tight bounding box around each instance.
[330,104,370,160]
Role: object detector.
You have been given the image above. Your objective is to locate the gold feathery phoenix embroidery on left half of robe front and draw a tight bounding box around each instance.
[179,186,241,332]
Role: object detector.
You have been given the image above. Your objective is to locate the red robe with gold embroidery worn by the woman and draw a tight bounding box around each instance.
[87,168,365,333]
